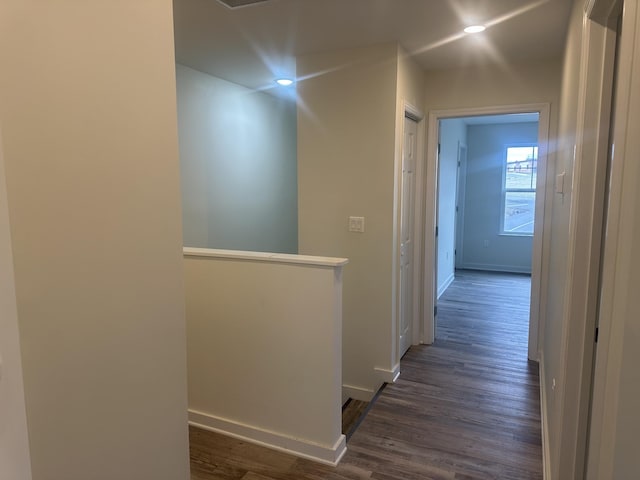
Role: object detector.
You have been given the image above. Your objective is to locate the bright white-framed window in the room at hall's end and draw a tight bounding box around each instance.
[502,145,538,235]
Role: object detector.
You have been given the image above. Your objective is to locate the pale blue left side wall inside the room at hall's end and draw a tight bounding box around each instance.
[437,118,467,297]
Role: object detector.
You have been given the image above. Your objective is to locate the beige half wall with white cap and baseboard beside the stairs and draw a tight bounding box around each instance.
[185,248,346,463]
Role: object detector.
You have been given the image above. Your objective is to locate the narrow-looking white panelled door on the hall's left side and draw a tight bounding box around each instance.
[399,117,418,356]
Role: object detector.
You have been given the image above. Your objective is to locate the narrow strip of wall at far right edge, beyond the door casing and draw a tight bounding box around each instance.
[598,0,640,480]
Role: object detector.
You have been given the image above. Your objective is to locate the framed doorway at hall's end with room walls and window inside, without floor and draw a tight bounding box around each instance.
[421,104,549,361]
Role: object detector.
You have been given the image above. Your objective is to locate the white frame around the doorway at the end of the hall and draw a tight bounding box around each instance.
[420,103,553,361]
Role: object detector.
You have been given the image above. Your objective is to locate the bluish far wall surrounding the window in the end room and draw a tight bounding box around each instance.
[460,122,538,273]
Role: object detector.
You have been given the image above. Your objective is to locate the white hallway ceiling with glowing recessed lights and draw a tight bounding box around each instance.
[173,0,571,93]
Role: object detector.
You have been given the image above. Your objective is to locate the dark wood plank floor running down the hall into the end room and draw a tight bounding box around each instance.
[190,272,542,480]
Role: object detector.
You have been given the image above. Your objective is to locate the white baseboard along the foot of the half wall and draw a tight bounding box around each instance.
[189,410,347,467]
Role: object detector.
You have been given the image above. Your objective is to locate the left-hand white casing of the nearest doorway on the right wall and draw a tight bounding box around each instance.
[556,0,620,478]
